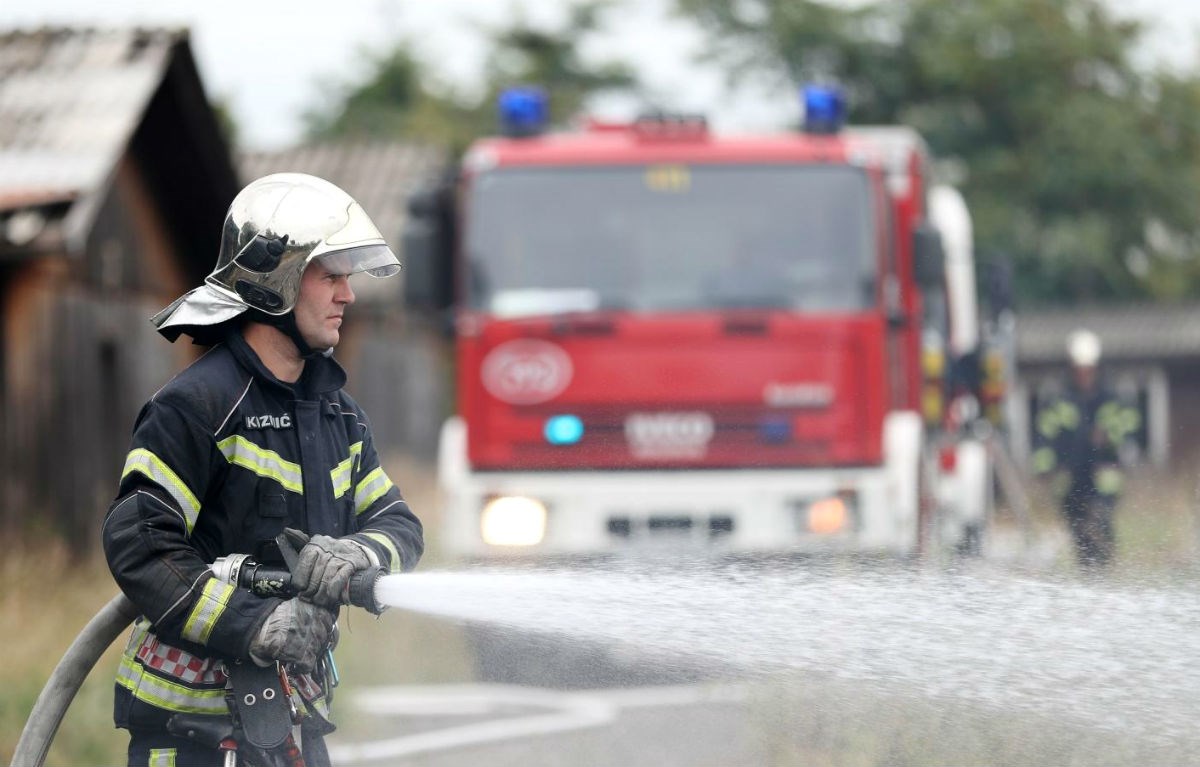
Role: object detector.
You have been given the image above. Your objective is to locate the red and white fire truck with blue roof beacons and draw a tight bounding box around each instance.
[404,86,992,558]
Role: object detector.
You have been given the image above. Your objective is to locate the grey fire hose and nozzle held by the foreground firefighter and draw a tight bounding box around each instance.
[12,535,386,767]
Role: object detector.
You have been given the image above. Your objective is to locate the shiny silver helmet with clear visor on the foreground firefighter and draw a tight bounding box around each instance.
[150,173,400,340]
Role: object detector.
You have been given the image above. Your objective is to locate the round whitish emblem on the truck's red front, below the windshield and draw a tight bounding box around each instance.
[481,338,572,405]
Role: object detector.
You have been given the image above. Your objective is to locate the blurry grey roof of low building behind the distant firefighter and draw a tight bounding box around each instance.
[1016,304,1200,364]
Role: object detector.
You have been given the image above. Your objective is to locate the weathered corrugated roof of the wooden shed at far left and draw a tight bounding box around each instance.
[0,28,187,242]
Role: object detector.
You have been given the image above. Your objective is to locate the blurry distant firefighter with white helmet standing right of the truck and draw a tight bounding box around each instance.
[1033,330,1141,569]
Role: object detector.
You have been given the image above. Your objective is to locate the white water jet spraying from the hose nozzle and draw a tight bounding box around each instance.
[377,565,1200,744]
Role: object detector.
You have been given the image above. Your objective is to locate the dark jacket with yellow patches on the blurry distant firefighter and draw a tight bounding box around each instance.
[1033,379,1141,496]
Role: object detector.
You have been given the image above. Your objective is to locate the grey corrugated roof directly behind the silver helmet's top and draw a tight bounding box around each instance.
[238,142,445,242]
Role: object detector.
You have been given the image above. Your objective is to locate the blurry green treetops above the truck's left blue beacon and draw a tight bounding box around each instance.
[305,1,636,152]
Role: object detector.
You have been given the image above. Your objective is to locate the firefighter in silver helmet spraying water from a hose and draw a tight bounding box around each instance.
[102,173,424,767]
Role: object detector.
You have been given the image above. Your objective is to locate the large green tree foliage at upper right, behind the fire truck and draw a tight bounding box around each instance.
[677,0,1200,302]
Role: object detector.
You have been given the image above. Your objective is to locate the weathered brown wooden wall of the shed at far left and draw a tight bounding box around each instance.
[2,273,178,552]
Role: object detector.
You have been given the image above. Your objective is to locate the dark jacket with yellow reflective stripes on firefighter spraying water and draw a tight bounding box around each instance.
[102,331,422,729]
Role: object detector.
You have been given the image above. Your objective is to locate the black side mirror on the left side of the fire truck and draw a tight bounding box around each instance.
[401,188,454,312]
